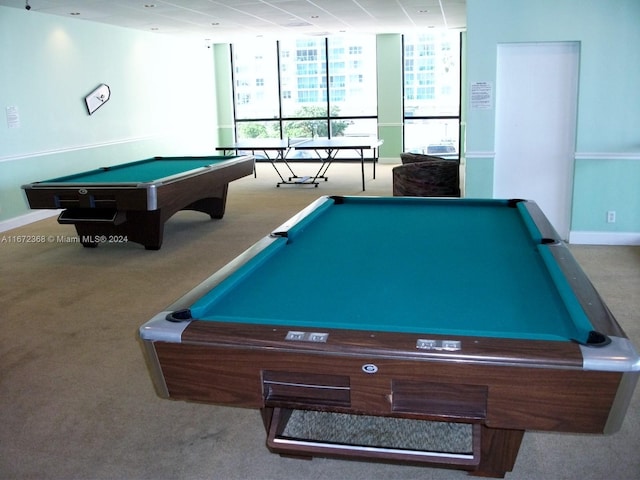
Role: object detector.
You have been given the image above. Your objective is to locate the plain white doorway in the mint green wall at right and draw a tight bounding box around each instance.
[493,42,580,240]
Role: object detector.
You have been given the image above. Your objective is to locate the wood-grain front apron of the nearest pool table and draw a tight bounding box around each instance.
[146,321,637,433]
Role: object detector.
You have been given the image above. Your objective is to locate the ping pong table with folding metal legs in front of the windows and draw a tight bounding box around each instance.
[216,137,383,191]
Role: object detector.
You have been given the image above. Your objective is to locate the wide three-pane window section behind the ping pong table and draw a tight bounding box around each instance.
[232,36,377,146]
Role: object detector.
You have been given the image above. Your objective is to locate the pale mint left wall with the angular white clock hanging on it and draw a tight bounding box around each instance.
[0,7,217,222]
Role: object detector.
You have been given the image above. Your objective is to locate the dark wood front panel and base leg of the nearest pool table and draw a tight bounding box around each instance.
[153,334,621,477]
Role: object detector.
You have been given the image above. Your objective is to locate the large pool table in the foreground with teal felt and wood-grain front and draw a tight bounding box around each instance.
[139,196,640,477]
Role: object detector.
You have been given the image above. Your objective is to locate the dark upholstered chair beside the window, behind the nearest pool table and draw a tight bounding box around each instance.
[392,153,460,197]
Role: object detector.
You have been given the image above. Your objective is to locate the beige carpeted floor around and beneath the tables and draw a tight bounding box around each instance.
[0,164,640,480]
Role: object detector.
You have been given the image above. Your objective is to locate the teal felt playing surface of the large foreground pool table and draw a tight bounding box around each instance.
[192,197,591,340]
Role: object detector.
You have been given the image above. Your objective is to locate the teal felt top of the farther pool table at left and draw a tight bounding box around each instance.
[41,156,235,184]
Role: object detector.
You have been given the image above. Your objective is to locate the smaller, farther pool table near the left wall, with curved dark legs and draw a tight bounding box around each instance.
[22,156,254,250]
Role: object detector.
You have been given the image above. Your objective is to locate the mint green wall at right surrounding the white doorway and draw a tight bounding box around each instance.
[466,0,640,242]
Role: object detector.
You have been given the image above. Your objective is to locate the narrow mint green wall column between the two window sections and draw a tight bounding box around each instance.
[376,34,403,162]
